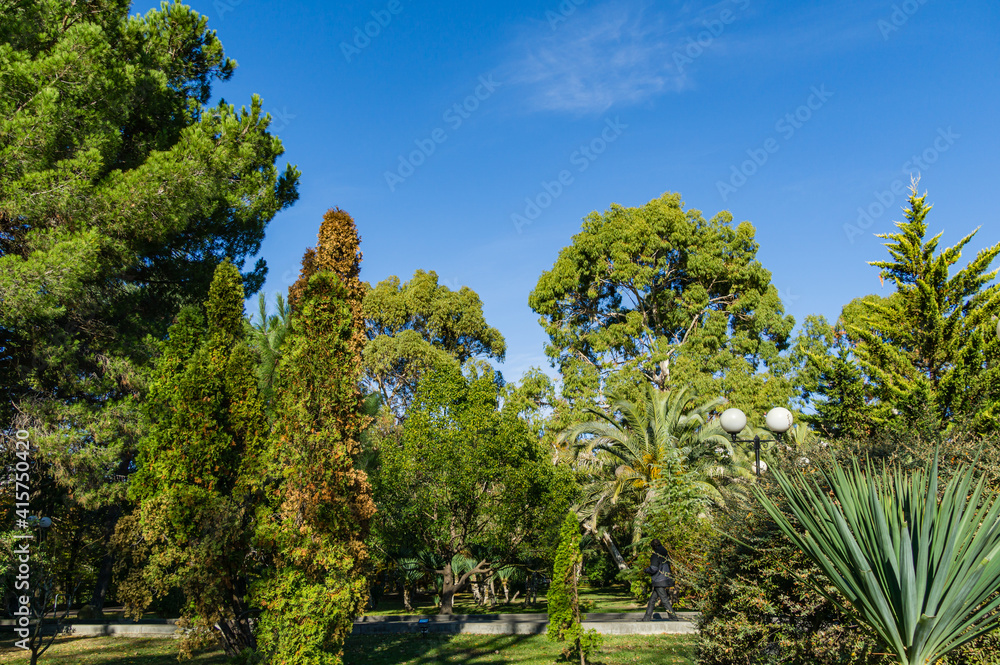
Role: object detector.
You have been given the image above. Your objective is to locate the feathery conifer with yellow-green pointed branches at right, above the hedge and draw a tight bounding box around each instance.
[847,183,1000,431]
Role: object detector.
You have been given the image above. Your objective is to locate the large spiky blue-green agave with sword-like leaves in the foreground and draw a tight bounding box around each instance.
[755,454,1000,665]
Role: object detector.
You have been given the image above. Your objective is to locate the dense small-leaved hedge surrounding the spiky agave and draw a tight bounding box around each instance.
[697,432,1000,665]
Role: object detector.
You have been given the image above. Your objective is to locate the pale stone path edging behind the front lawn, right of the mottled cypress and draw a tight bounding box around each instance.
[354,612,698,635]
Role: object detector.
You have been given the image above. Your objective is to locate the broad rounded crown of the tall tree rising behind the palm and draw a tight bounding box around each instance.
[529,189,793,412]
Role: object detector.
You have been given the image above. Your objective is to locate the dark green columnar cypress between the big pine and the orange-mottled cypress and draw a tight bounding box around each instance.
[130,261,266,655]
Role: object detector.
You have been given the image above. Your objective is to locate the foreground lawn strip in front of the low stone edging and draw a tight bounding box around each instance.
[0,634,695,665]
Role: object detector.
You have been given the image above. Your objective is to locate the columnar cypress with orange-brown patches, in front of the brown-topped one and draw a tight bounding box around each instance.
[255,272,375,665]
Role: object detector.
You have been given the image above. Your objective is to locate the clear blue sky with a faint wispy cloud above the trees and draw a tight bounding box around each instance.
[139,0,1000,380]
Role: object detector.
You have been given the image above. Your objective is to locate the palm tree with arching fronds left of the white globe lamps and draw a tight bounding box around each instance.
[557,386,740,548]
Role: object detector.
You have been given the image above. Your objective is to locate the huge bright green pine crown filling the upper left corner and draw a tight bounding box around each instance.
[0,0,298,504]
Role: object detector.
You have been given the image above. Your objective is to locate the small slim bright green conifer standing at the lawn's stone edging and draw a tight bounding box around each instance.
[547,513,601,665]
